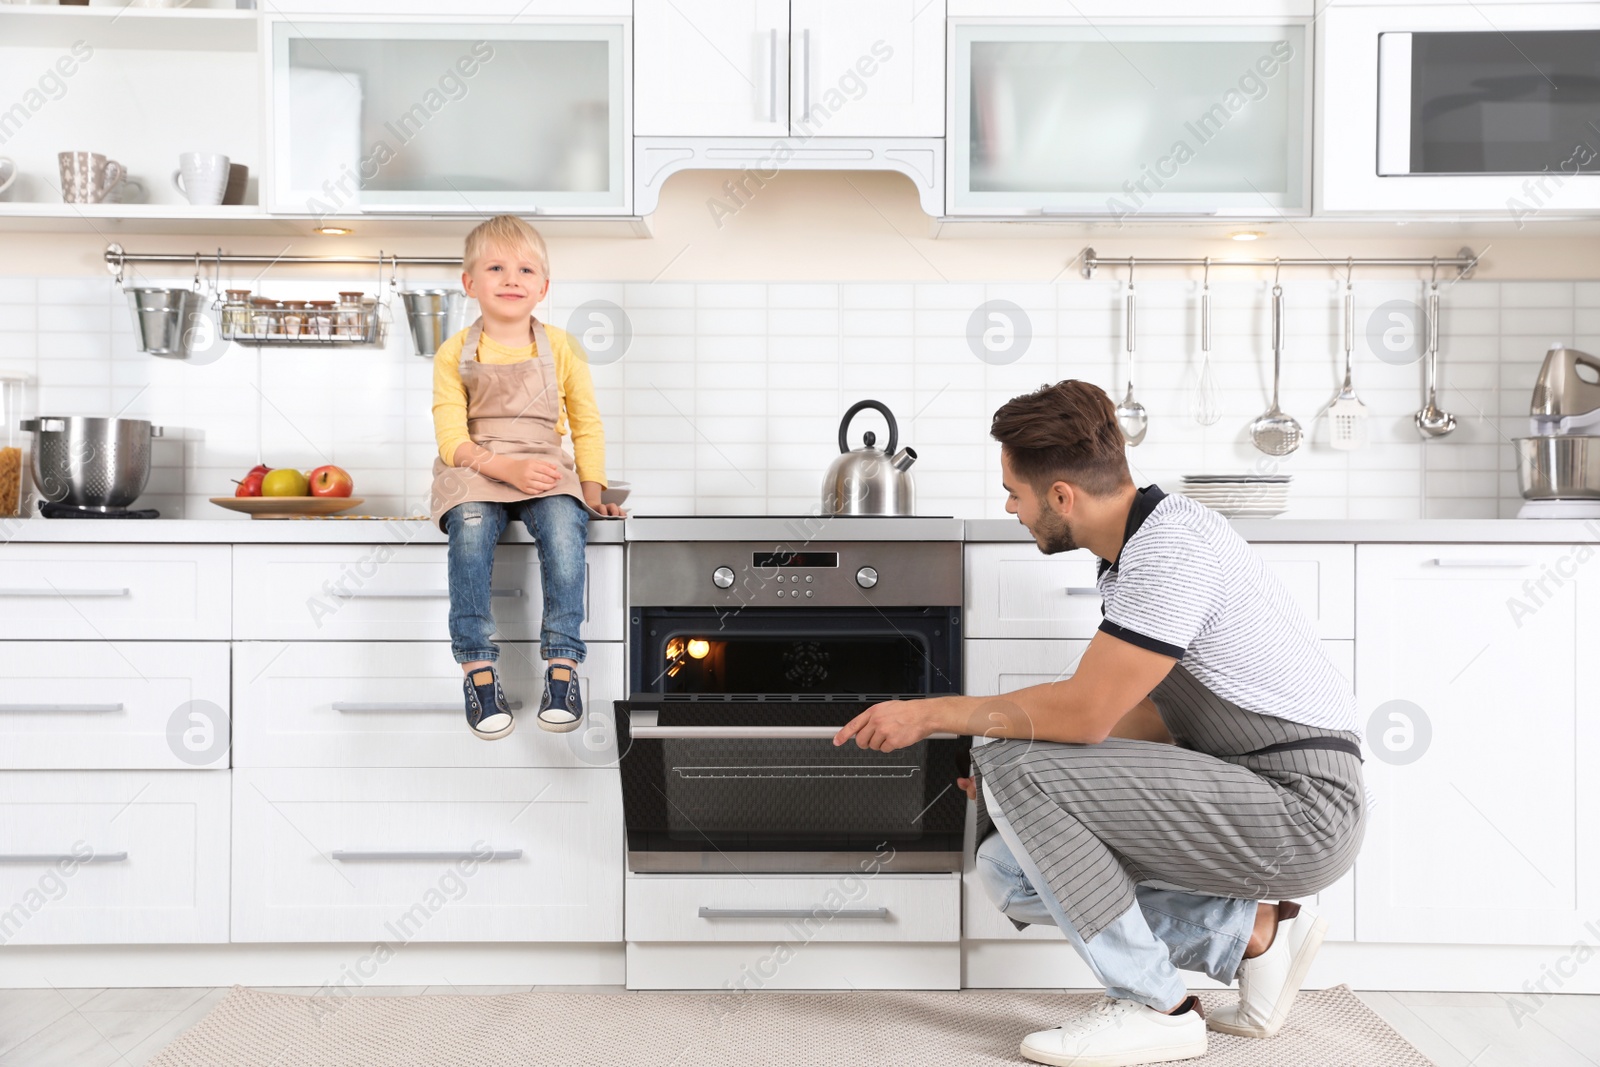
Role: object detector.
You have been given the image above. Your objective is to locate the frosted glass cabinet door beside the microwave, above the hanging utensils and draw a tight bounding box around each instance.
[949,22,1310,218]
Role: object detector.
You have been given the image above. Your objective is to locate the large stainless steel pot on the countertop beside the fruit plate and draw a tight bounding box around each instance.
[22,416,162,512]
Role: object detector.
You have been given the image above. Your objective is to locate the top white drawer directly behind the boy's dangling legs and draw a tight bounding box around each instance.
[234,544,626,641]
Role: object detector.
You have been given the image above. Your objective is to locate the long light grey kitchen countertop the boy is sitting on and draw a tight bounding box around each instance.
[0,515,1600,544]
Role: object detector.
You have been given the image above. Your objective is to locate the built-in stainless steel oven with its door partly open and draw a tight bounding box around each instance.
[616,539,971,875]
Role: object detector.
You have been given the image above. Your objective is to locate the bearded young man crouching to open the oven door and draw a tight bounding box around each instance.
[835,381,1365,1067]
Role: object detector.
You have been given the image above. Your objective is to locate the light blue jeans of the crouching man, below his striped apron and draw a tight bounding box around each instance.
[978,784,1256,1011]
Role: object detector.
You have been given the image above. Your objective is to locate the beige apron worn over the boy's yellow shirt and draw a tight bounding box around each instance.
[429,318,587,530]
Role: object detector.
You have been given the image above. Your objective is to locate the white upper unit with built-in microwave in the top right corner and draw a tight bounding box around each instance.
[1318,3,1600,214]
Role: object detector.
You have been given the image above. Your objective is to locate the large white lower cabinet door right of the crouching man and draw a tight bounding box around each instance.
[1357,544,1600,945]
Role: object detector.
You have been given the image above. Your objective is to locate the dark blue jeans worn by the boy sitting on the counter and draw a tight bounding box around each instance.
[445,496,589,664]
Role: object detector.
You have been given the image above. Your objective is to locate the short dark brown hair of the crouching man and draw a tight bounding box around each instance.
[989,378,1133,496]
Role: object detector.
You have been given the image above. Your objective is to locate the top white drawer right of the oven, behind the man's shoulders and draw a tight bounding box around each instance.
[965,542,1355,640]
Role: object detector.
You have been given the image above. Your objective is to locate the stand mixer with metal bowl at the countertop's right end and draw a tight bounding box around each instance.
[1514,344,1600,518]
